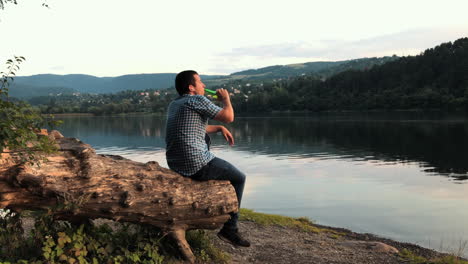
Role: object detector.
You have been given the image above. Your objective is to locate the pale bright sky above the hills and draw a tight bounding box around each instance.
[0,0,468,77]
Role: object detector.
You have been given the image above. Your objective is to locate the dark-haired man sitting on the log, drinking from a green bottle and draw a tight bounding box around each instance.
[166,71,250,247]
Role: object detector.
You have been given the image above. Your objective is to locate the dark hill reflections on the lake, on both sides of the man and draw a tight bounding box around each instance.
[60,115,468,182]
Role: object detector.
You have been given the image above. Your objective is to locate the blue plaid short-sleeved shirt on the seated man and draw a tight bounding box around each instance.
[166,94,222,176]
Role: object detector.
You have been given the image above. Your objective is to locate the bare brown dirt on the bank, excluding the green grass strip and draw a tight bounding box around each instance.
[210,222,458,264]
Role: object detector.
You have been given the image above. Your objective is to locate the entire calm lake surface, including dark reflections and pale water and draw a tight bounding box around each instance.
[60,113,468,255]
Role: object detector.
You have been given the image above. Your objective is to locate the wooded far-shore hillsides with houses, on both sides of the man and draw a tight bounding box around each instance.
[26,38,468,114]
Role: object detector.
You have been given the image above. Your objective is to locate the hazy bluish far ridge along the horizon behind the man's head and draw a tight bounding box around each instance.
[10,56,398,98]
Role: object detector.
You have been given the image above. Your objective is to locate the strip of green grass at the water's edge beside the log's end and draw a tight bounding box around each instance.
[240,208,342,236]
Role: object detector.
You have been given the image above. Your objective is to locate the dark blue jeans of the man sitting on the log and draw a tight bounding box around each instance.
[190,157,245,231]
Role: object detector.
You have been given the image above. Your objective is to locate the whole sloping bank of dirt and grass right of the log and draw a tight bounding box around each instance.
[210,208,468,264]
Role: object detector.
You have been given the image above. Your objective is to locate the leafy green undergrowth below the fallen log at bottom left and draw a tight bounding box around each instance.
[0,211,230,264]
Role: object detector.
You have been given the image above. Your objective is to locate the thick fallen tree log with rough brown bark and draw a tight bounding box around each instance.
[0,131,238,262]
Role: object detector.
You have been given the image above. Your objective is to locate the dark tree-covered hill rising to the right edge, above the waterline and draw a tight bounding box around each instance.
[233,38,468,113]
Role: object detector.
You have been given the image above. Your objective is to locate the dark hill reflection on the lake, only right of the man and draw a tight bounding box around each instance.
[227,118,468,180]
